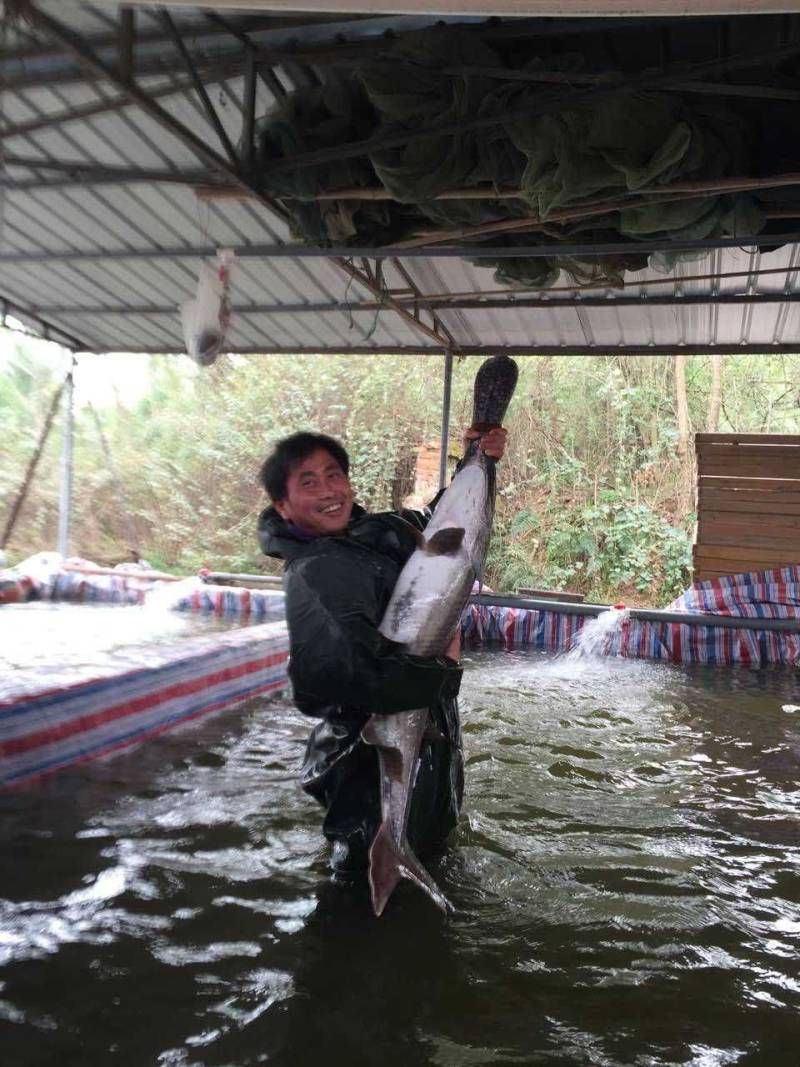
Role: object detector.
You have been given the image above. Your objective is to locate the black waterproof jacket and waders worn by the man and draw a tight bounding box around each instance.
[258,506,463,866]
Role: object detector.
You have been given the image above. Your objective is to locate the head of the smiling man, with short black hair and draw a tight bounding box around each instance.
[261,433,353,535]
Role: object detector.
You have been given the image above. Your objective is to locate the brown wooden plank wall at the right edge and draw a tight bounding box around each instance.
[694,433,800,582]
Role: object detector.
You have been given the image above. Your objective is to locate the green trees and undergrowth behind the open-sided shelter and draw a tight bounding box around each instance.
[0,341,800,604]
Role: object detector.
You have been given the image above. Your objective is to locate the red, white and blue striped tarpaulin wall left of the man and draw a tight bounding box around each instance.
[0,622,289,787]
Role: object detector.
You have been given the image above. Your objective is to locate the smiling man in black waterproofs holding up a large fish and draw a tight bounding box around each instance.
[258,428,506,873]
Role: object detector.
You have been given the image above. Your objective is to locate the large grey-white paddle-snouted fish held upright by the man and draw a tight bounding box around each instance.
[362,355,517,915]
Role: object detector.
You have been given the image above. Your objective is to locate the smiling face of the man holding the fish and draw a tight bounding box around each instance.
[275,448,353,535]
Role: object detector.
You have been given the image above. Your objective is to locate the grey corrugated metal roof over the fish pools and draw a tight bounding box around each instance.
[0,0,800,352]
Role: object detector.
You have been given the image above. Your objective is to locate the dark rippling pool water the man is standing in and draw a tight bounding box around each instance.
[0,652,800,1067]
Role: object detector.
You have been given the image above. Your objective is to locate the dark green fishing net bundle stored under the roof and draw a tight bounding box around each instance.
[247,27,800,286]
